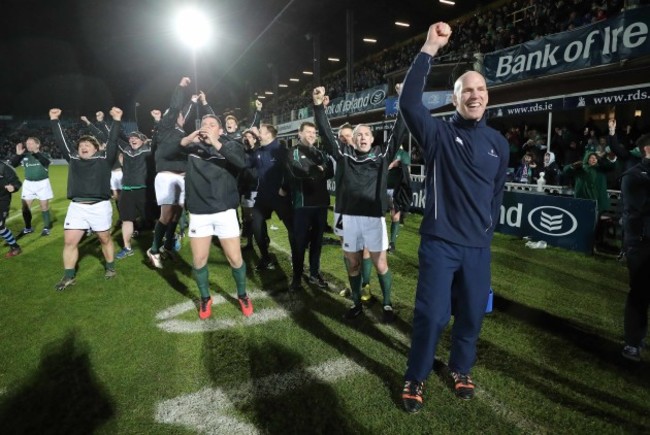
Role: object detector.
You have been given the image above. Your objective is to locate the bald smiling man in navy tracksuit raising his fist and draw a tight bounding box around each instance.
[399,23,509,412]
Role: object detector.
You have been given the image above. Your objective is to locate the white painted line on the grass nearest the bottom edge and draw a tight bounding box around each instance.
[155,358,367,435]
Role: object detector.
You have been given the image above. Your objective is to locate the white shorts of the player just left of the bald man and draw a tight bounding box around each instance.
[343,214,388,252]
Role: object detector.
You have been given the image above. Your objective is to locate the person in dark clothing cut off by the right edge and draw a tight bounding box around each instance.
[621,134,650,362]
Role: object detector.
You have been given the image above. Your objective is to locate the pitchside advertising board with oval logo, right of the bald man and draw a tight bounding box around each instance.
[496,191,597,253]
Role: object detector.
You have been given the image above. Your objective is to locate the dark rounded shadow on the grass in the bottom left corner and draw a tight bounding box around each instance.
[0,332,115,434]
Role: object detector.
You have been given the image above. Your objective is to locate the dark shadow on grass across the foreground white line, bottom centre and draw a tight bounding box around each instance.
[246,343,369,434]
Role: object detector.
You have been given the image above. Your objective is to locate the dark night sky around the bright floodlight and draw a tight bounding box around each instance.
[0,0,476,119]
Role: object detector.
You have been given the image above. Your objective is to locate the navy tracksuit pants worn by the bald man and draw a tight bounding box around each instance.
[404,235,490,381]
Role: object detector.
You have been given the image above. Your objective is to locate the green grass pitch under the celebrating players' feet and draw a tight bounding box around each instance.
[0,167,650,434]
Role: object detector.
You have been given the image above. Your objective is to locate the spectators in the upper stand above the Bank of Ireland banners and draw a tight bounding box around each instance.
[271,0,625,119]
